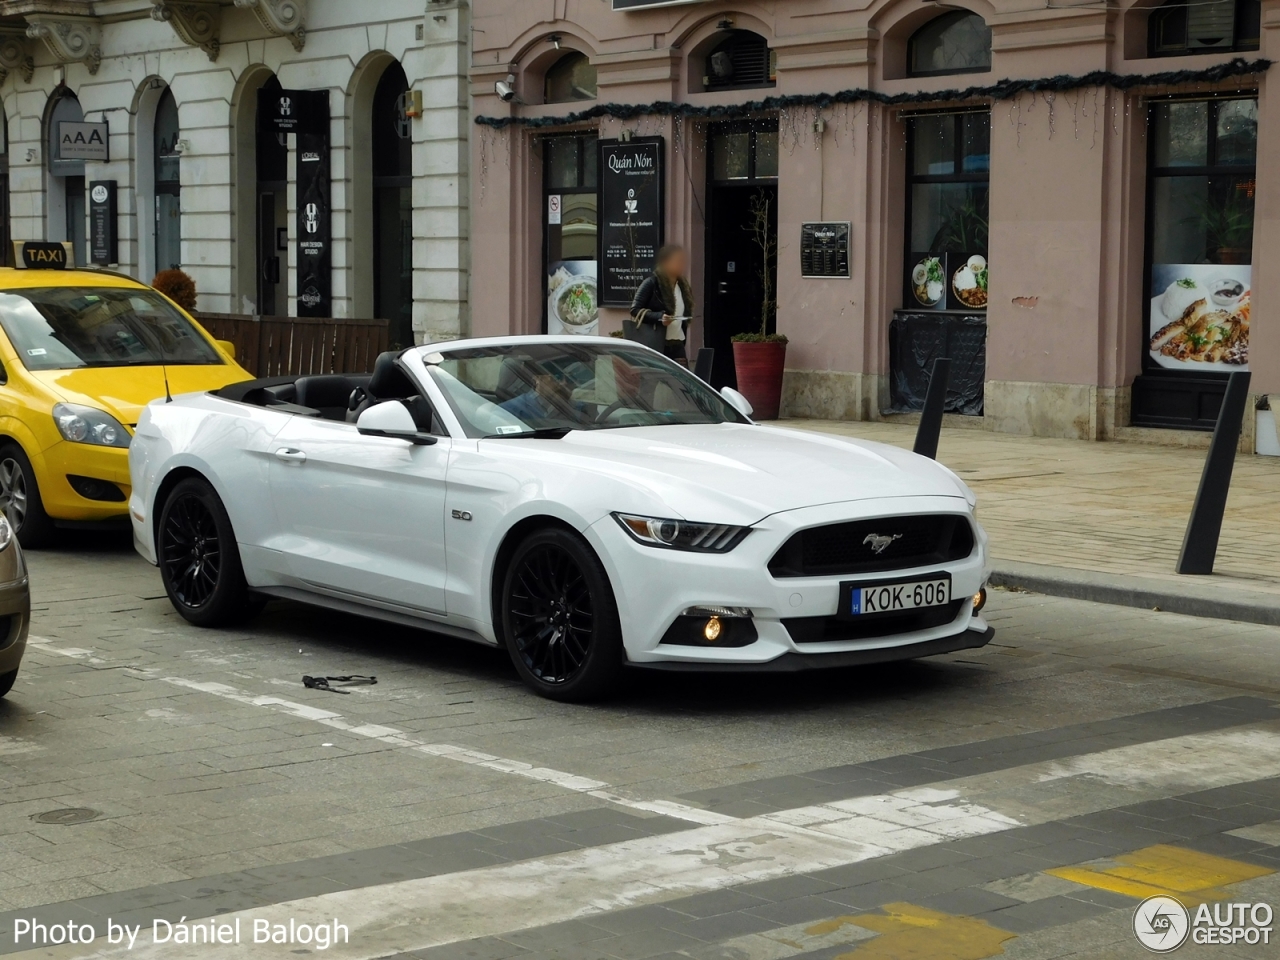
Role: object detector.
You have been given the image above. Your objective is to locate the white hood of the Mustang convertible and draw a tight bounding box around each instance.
[492,424,968,522]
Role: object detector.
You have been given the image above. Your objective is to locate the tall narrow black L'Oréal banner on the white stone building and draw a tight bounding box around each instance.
[297,91,333,316]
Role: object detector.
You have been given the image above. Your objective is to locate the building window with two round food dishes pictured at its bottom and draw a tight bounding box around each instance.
[905,110,991,310]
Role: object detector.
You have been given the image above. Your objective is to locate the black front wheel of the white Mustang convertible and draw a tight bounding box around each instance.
[502,529,622,700]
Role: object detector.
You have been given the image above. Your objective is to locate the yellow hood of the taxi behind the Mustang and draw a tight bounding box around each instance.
[31,364,244,425]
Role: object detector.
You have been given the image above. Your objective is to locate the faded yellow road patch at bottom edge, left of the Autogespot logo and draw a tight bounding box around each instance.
[829,904,1016,960]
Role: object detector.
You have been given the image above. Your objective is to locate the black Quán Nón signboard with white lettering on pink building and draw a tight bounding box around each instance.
[596,137,666,307]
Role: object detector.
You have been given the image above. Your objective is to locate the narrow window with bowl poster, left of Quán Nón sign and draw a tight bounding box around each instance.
[541,133,599,334]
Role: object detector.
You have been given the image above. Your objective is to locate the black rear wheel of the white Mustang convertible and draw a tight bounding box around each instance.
[156,477,264,627]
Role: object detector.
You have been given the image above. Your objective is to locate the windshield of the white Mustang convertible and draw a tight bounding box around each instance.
[428,342,746,436]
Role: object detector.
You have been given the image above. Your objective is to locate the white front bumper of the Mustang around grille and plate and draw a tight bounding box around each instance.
[588,497,992,671]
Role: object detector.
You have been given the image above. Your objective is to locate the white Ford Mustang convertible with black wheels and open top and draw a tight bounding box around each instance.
[129,337,992,700]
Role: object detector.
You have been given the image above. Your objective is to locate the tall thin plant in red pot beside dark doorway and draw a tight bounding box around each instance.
[731,192,787,420]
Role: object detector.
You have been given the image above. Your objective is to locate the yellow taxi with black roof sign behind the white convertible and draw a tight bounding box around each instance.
[0,243,251,547]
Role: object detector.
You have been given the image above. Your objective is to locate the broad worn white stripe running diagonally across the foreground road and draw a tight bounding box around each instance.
[17,722,1280,960]
